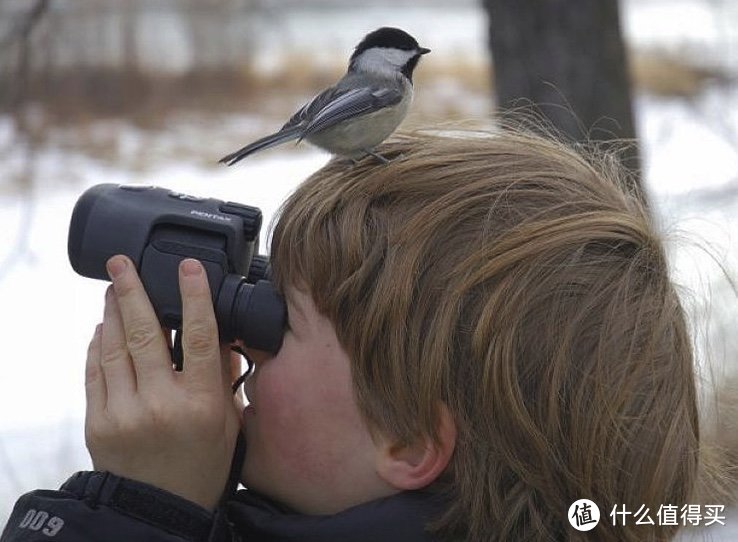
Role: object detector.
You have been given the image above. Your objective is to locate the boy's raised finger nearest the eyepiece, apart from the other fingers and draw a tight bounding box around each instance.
[179,258,222,389]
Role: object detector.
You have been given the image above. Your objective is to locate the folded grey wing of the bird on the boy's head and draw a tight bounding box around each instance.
[283,86,402,139]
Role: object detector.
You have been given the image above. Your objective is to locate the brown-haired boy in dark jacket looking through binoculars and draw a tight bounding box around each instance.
[2,132,699,542]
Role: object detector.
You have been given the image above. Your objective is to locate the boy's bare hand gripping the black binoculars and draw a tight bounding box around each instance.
[85,256,240,510]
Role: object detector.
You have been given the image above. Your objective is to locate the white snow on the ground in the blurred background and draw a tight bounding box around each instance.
[0,0,738,541]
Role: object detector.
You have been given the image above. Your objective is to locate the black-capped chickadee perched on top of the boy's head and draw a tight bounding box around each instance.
[220,27,430,166]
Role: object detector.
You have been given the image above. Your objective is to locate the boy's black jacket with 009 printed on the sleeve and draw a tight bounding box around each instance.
[0,472,443,542]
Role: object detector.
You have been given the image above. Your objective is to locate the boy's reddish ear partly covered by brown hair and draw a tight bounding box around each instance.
[377,404,456,491]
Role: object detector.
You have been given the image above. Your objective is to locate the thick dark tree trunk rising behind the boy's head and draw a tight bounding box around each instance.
[483,0,645,201]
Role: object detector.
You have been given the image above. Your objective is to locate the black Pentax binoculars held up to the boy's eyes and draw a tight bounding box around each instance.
[68,184,287,360]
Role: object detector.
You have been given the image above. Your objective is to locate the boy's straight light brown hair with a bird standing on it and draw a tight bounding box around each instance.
[250,131,698,540]
